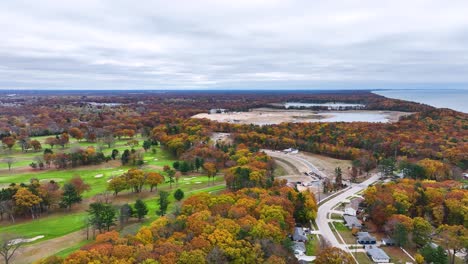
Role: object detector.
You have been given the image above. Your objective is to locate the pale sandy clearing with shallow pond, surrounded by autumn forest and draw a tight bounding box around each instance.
[193,108,411,125]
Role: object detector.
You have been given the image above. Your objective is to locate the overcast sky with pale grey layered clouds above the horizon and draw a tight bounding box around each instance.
[0,0,468,89]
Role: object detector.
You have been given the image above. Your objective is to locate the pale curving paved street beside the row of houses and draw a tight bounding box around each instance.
[315,175,379,251]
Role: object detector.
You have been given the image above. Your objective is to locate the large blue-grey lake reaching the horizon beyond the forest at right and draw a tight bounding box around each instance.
[373,89,468,113]
